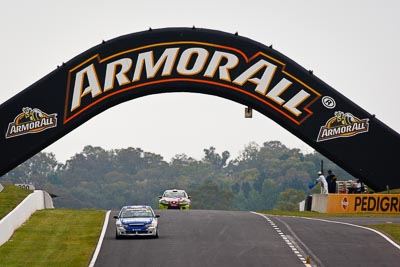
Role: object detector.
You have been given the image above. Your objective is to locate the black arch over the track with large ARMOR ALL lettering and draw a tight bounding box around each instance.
[0,28,400,190]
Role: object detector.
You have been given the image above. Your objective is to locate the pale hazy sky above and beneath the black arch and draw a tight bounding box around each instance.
[0,0,400,162]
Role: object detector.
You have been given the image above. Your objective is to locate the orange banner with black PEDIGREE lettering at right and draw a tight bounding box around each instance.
[326,194,400,214]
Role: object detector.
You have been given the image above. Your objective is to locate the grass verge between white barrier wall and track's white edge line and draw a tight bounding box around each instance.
[0,209,105,267]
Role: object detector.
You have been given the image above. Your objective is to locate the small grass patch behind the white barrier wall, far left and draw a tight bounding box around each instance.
[0,185,32,220]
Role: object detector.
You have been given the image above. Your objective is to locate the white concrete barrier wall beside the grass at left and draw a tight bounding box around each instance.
[0,190,54,246]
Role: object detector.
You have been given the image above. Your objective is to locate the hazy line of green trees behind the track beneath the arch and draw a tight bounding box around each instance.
[0,141,353,213]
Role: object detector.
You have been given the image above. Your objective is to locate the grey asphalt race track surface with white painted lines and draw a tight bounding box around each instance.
[94,210,400,267]
